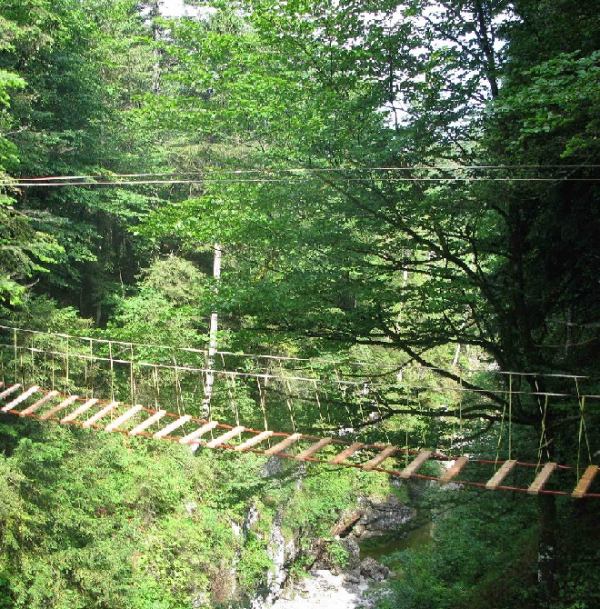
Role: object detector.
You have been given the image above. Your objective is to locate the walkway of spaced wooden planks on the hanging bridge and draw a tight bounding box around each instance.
[0,383,600,499]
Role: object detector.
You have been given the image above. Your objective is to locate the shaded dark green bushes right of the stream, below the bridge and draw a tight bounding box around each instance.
[377,490,537,609]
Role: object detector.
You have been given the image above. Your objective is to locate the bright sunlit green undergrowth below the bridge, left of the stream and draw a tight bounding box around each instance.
[0,396,386,609]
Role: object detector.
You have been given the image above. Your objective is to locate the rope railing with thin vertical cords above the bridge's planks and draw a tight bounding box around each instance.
[0,325,600,480]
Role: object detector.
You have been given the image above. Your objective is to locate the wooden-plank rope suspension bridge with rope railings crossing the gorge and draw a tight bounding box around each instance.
[0,326,600,498]
